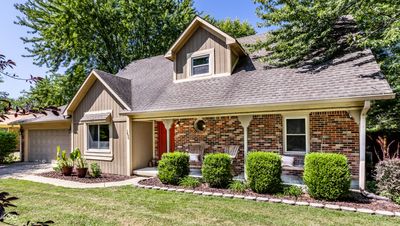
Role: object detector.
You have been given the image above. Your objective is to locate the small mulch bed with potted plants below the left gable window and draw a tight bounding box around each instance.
[37,171,132,184]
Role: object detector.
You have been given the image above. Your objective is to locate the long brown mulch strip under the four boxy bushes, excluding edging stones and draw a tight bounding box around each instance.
[139,178,400,212]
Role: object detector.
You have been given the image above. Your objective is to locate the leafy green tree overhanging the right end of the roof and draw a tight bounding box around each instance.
[253,0,400,130]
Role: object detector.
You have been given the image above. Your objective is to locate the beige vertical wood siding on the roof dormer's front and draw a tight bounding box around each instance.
[176,27,229,80]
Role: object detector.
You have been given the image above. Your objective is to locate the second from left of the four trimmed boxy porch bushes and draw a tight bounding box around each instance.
[201,153,233,188]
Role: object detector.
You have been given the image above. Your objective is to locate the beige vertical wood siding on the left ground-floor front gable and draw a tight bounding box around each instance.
[73,81,127,175]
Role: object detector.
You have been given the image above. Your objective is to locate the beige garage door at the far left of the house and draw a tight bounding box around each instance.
[28,129,71,162]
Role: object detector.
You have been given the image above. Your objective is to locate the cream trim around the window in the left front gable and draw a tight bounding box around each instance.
[84,121,113,161]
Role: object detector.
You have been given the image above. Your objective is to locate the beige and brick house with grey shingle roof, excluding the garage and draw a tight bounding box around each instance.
[14,17,394,188]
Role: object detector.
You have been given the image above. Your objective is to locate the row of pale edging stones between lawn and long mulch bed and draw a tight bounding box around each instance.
[133,181,400,217]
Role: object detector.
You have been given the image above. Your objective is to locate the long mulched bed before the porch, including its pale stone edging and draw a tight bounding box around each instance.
[139,178,400,216]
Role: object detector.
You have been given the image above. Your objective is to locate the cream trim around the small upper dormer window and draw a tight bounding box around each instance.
[186,48,215,78]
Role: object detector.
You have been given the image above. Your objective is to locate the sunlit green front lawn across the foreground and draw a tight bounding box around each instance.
[0,179,400,225]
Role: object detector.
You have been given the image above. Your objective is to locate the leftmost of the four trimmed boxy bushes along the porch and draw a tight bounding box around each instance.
[158,151,189,185]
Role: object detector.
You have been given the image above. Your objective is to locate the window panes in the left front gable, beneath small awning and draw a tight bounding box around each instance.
[87,124,110,150]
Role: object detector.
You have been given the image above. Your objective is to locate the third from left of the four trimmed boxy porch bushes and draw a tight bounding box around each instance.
[246,152,282,193]
